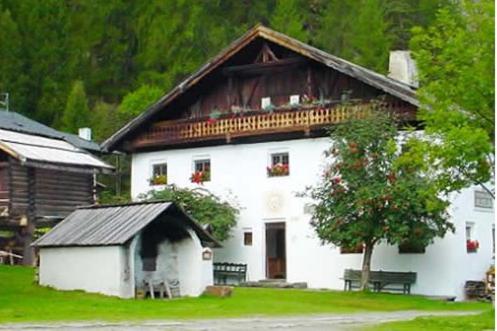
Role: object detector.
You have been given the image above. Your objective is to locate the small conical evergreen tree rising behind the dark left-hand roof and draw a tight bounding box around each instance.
[62,80,90,133]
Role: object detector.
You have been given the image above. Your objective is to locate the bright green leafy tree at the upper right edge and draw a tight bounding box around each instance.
[411,0,495,196]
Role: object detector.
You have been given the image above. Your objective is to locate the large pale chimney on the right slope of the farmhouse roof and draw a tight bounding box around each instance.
[388,51,418,87]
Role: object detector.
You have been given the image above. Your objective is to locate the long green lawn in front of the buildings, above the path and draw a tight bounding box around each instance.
[0,266,490,323]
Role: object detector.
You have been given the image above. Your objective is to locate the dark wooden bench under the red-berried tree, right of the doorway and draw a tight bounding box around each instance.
[343,269,416,294]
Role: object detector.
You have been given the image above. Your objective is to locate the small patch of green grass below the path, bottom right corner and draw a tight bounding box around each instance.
[366,309,495,331]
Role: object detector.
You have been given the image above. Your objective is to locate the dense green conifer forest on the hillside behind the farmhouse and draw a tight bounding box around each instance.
[0,0,454,141]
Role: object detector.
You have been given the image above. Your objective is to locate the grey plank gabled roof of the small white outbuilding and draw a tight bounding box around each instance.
[33,201,221,247]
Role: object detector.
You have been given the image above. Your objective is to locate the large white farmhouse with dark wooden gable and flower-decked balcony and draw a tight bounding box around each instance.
[104,26,494,299]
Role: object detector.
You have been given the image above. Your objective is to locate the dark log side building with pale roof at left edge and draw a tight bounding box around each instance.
[0,111,113,264]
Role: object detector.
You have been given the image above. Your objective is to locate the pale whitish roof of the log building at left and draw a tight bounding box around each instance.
[0,129,114,172]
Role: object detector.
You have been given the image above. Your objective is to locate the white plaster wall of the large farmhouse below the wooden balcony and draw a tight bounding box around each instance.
[131,138,493,299]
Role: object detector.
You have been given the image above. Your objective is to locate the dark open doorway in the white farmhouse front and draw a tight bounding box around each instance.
[266,222,286,279]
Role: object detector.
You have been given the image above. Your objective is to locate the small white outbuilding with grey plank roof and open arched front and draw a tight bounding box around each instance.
[33,202,220,298]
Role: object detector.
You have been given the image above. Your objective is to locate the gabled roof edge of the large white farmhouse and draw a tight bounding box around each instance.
[102,25,419,151]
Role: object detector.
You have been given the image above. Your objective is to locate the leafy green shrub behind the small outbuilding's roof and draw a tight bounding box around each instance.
[141,185,238,241]
